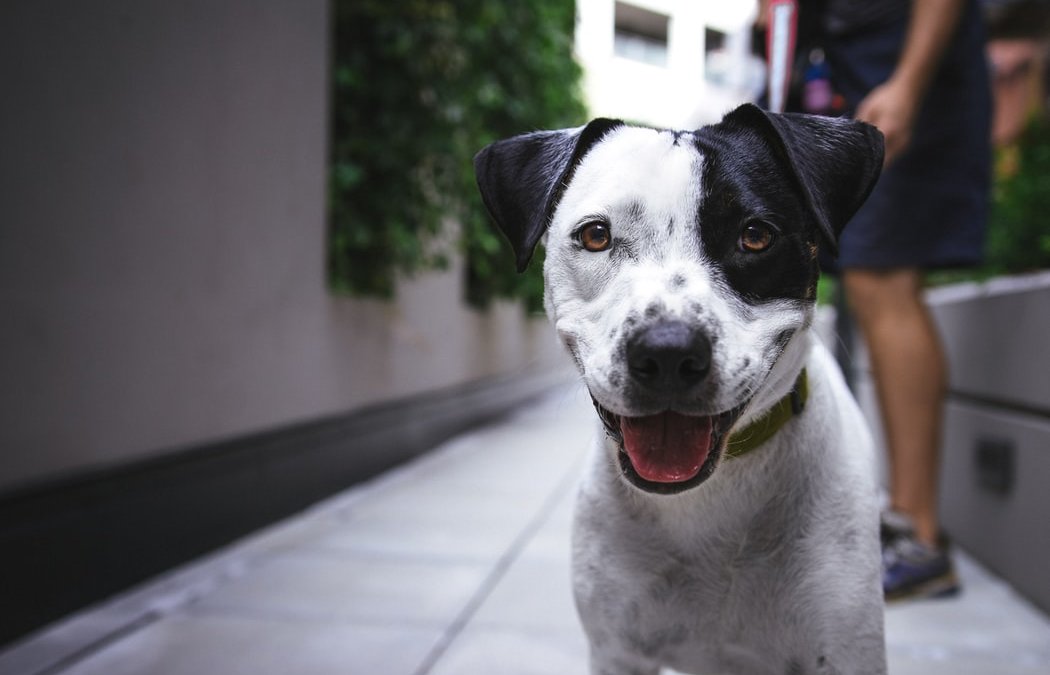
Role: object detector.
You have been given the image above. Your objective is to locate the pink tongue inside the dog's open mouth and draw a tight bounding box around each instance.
[620,412,712,483]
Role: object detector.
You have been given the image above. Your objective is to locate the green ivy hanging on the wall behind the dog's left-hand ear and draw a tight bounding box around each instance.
[329,0,586,309]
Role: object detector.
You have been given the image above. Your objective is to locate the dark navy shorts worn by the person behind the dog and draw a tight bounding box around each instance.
[825,2,991,270]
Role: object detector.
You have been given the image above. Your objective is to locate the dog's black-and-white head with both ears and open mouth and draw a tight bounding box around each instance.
[475,105,882,492]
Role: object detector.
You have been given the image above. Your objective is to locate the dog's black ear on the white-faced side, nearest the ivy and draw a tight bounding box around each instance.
[474,119,624,272]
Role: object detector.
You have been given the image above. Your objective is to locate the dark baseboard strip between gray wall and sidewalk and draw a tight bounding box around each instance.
[0,372,567,646]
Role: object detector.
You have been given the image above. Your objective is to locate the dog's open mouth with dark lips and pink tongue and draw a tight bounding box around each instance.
[594,401,744,494]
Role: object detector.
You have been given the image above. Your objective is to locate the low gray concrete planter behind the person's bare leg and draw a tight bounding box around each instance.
[854,272,1050,611]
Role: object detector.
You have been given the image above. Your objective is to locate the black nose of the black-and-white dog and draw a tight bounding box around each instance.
[627,321,711,393]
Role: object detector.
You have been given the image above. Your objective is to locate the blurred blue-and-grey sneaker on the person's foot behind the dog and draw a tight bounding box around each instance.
[881,513,960,602]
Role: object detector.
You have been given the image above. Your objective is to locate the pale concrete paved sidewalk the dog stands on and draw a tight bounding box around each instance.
[6,388,1050,675]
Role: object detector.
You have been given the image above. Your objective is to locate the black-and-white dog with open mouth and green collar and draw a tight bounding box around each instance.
[475,104,886,675]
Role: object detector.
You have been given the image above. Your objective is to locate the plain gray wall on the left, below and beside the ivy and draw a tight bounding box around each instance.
[0,0,565,491]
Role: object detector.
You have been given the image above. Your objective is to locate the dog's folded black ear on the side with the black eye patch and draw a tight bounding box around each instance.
[722,104,884,254]
